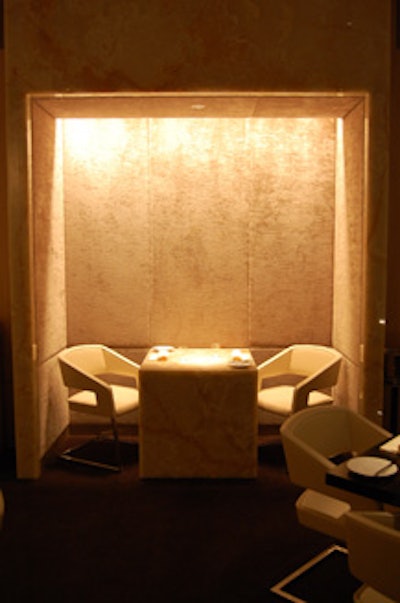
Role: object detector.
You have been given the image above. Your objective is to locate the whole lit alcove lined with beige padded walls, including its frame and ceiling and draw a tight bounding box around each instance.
[28,93,368,454]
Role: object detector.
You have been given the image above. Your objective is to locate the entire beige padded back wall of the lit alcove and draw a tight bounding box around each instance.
[63,118,336,348]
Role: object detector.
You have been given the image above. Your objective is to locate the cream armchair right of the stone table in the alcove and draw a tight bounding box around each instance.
[258,344,342,418]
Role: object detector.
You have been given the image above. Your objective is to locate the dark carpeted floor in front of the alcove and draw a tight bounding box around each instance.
[0,435,355,603]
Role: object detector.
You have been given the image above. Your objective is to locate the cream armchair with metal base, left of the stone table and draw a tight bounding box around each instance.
[58,344,139,469]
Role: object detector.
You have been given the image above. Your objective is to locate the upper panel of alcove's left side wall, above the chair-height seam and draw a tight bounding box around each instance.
[32,105,66,363]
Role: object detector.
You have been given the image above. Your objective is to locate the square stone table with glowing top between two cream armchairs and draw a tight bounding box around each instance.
[139,347,257,478]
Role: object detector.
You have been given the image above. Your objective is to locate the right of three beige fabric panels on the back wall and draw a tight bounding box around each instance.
[250,119,335,346]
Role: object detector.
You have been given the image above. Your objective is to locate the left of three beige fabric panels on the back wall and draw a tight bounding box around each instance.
[64,120,151,347]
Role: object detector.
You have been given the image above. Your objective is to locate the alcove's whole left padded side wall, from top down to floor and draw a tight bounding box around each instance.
[32,106,69,454]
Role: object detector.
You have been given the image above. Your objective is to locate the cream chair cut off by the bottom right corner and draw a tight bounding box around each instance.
[346,512,400,603]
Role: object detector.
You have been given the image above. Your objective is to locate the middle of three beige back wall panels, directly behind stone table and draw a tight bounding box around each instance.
[150,119,250,346]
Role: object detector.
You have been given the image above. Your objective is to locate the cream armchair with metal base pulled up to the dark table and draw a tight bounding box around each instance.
[271,405,391,603]
